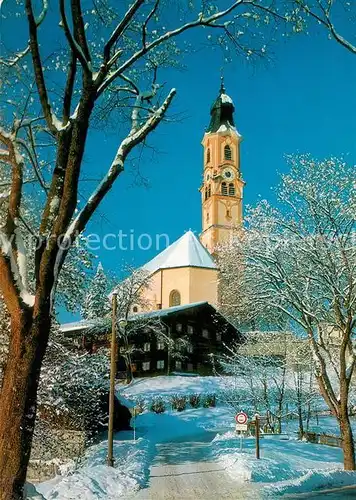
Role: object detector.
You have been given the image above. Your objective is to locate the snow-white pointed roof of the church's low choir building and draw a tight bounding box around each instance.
[143,231,217,273]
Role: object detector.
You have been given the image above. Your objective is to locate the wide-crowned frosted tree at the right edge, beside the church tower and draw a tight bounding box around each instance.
[221,156,356,469]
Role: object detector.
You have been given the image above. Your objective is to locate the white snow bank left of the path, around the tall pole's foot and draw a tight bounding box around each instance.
[37,433,152,500]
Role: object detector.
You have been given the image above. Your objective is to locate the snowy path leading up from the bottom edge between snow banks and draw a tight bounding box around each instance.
[132,432,259,500]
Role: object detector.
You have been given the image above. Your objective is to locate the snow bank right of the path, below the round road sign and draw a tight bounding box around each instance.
[212,431,356,498]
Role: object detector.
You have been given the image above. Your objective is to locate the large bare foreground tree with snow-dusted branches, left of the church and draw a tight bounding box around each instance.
[0,0,306,498]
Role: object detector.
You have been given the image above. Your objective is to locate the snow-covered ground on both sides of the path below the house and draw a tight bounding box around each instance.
[37,376,356,500]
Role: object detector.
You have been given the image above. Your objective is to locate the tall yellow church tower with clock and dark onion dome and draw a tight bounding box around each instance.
[200,81,245,253]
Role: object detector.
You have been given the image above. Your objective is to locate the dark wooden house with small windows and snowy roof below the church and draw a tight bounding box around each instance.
[63,302,239,378]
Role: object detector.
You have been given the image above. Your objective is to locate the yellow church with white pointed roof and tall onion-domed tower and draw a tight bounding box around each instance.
[132,77,244,313]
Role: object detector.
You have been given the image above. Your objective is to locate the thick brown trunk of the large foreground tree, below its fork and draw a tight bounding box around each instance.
[0,310,51,500]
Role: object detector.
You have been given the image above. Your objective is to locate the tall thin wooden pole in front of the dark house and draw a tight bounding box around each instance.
[107,293,117,467]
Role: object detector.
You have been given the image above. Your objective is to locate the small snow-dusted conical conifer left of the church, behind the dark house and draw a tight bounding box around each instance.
[82,263,110,319]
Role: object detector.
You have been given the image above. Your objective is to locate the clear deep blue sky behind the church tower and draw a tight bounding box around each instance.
[81,24,356,273]
